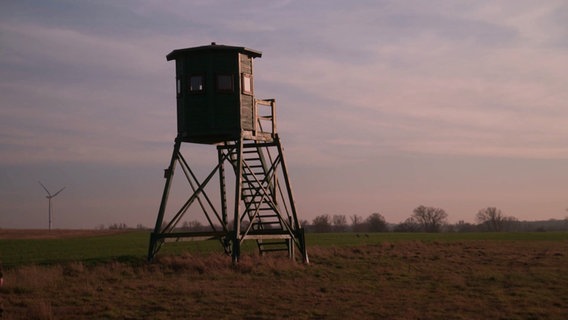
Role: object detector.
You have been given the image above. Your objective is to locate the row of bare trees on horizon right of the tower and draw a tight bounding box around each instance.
[301,205,568,232]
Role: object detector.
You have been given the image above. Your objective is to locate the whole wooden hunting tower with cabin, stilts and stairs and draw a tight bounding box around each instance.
[148,43,308,263]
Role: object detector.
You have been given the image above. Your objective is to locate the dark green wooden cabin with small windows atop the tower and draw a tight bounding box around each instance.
[166,43,262,144]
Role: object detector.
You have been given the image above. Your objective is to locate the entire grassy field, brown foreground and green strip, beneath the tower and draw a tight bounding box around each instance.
[0,230,568,319]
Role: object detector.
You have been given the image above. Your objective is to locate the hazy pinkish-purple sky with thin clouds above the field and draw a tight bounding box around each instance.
[0,0,568,229]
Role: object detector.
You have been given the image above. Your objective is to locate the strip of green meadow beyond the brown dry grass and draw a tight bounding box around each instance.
[0,231,568,268]
